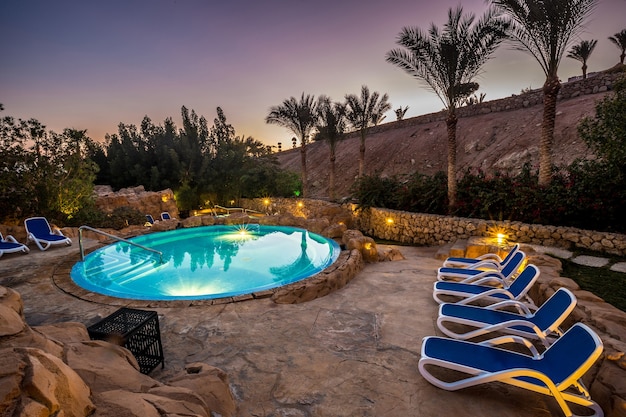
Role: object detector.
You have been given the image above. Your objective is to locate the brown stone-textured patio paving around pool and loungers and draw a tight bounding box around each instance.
[0,240,560,417]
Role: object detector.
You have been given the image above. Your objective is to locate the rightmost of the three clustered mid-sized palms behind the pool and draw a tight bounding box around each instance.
[346,86,391,177]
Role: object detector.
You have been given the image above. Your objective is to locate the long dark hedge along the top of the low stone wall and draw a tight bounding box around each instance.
[353,161,626,233]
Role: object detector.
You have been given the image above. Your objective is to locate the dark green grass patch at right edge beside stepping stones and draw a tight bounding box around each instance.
[561,254,626,312]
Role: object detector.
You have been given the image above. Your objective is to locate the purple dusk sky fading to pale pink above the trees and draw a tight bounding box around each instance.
[0,0,626,148]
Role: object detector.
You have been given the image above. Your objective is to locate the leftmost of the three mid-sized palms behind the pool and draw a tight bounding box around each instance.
[265,93,317,197]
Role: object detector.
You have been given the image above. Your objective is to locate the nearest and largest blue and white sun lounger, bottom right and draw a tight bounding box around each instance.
[418,323,604,417]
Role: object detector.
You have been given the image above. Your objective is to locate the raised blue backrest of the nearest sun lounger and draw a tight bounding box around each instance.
[537,323,603,386]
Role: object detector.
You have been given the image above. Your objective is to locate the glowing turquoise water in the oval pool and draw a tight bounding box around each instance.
[70,225,340,300]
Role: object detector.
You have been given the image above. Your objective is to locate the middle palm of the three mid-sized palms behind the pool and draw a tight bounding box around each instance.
[315,96,346,201]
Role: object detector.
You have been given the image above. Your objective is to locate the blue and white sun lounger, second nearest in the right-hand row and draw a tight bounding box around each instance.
[437,288,576,347]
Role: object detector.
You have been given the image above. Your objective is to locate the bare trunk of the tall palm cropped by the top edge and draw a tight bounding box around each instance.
[539,75,561,186]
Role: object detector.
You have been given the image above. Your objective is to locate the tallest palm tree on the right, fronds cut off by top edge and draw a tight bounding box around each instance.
[491,0,598,185]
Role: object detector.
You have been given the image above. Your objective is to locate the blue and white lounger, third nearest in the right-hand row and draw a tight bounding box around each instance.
[433,264,539,306]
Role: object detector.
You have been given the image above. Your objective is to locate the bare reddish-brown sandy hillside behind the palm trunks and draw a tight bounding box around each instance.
[277,92,607,198]
